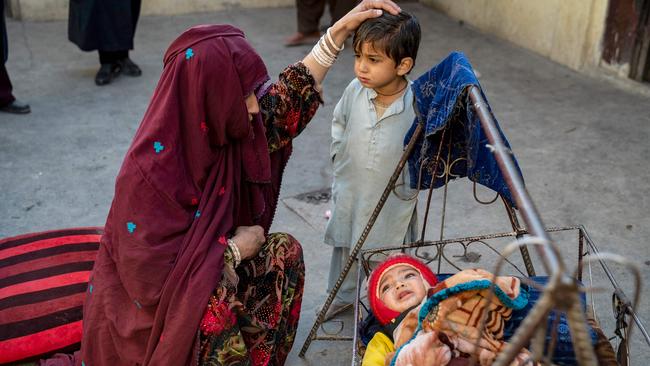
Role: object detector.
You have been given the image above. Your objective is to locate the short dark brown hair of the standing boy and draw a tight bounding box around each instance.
[352,11,421,64]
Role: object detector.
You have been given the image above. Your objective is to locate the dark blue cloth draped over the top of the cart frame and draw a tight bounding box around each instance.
[404,52,521,207]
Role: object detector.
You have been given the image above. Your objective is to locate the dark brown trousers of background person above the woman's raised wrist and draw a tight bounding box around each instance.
[296,0,358,34]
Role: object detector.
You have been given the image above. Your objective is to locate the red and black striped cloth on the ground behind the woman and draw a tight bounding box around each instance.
[0,227,102,364]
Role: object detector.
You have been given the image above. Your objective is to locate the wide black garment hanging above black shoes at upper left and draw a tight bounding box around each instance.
[68,0,141,51]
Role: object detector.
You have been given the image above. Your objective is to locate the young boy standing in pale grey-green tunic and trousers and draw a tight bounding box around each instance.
[325,11,420,319]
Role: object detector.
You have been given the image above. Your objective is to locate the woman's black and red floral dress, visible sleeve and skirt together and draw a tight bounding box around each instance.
[199,63,322,366]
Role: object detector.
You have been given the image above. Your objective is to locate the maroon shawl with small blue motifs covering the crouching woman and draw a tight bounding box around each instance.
[77,25,278,366]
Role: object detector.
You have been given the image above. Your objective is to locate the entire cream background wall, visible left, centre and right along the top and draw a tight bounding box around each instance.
[8,0,630,79]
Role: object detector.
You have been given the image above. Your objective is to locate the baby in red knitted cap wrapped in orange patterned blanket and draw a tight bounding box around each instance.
[362,254,533,366]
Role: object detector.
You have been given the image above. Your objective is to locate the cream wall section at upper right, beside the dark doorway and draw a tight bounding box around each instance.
[421,0,608,70]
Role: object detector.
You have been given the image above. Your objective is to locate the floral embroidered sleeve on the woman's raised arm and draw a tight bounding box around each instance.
[260,62,323,153]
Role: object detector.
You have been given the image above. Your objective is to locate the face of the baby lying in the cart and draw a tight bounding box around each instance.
[379,265,427,313]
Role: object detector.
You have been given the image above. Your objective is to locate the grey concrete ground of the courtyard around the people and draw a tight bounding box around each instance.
[0,3,650,365]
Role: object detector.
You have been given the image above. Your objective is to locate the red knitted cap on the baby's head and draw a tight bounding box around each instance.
[368,254,438,325]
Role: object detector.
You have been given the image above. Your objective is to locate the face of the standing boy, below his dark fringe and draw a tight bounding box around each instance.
[354,42,401,89]
